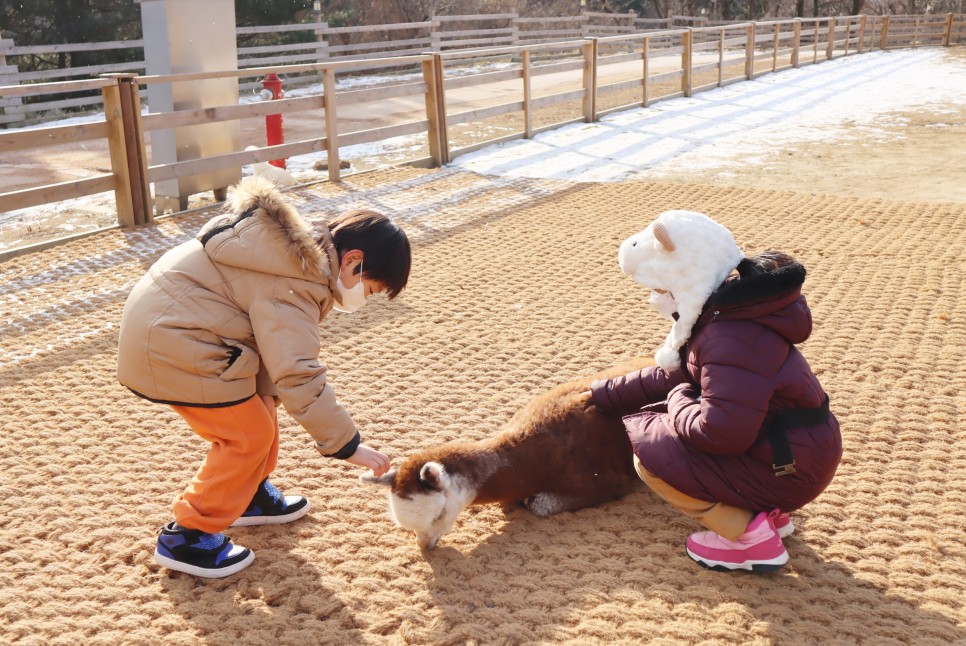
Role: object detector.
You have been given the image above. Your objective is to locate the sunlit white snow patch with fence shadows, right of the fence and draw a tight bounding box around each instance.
[452,49,966,182]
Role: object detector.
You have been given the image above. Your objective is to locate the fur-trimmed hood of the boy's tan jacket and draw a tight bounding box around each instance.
[198,176,338,288]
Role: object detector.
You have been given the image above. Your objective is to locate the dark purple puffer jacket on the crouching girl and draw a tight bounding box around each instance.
[591,254,842,512]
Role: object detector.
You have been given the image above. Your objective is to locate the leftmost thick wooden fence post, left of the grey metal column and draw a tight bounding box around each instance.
[102,74,152,227]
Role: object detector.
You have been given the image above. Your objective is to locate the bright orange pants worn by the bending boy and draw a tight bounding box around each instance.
[171,396,278,534]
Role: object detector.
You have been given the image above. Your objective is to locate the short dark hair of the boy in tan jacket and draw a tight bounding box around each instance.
[329,209,412,298]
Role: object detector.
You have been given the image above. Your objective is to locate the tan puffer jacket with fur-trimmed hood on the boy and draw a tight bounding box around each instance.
[117,177,359,457]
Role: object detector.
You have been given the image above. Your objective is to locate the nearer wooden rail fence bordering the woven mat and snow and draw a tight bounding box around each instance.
[0,15,966,256]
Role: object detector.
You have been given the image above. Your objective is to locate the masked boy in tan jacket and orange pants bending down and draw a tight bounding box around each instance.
[118,177,411,577]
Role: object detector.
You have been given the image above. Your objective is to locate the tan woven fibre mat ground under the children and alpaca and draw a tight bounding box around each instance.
[0,169,966,645]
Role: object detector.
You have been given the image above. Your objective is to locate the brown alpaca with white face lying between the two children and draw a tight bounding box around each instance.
[360,359,653,549]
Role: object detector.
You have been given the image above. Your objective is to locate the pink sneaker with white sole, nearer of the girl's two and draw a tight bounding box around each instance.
[687,509,788,572]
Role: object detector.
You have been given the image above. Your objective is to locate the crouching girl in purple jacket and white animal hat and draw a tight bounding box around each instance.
[591,211,842,572]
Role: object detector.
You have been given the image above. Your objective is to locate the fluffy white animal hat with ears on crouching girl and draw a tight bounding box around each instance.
[617,211,744,370]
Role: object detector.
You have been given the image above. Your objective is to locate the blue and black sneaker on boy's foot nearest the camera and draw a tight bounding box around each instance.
[154,522,255,579]
